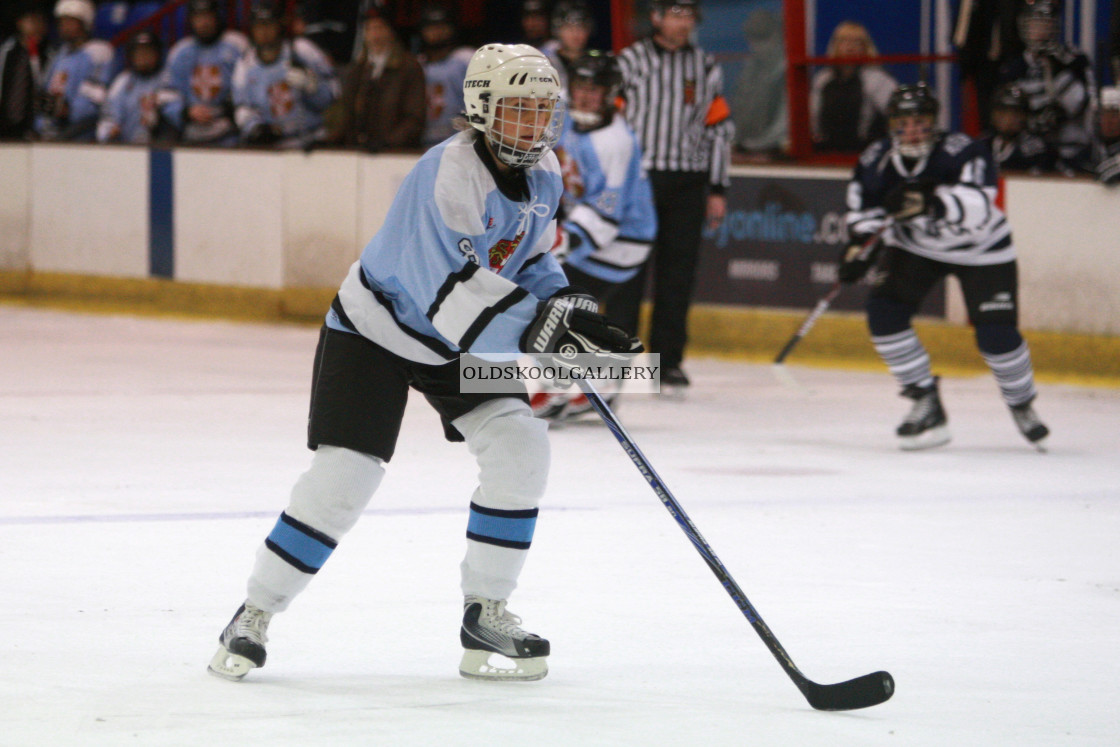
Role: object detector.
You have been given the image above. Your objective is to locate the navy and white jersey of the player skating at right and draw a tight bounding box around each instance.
[847,133,1015,265]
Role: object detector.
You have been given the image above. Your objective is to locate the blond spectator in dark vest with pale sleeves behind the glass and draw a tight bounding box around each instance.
[809,21,898,153]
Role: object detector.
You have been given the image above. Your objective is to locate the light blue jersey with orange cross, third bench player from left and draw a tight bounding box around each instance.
[162,30,249,142]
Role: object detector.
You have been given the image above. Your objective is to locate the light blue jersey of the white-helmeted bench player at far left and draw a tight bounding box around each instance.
[35,39,113,141]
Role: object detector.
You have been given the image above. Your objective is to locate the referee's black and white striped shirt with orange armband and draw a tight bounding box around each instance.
[618,38,735,188]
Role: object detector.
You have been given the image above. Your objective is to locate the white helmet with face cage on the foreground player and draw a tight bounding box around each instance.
[463,44,563,169]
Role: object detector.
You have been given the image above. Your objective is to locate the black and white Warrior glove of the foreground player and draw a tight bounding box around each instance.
[521,295,643,368]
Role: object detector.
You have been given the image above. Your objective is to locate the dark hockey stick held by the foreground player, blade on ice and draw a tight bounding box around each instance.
[576,379,895,711]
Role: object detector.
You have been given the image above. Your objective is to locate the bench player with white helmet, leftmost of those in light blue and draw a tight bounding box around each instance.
[35,0,113,142]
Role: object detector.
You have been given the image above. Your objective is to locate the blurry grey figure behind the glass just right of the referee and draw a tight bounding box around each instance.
[731,8,790,155]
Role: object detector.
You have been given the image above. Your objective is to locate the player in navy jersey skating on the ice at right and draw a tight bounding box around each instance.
[839,84,1049,449]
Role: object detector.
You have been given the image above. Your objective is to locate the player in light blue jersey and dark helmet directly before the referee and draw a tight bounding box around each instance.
[531,52,657,420]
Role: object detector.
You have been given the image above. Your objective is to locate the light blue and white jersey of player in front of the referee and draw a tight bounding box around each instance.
[557,114,657,283]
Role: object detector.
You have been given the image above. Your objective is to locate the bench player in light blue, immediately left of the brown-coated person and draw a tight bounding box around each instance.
[233,0,338,148]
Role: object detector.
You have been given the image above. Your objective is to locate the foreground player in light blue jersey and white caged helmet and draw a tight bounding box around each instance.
[209,44,641,680]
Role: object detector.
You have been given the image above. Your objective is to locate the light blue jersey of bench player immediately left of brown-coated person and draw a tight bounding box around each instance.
[233,38,338,144]
